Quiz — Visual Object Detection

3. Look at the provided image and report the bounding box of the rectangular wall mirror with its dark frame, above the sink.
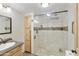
[0,15,12,34]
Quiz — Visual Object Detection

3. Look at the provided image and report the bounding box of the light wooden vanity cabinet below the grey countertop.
[3,46,23,56]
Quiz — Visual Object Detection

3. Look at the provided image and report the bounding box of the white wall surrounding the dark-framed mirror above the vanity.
[0,9,24,42]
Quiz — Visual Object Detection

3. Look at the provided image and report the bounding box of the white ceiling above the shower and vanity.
[4,3,68,14]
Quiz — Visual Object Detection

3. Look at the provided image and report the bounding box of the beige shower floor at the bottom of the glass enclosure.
[35,50,65,56]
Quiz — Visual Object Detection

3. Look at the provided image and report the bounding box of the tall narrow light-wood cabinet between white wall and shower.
[24,16,31,53]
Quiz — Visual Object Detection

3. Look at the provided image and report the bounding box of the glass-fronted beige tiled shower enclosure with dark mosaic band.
[33,10,68,56]
